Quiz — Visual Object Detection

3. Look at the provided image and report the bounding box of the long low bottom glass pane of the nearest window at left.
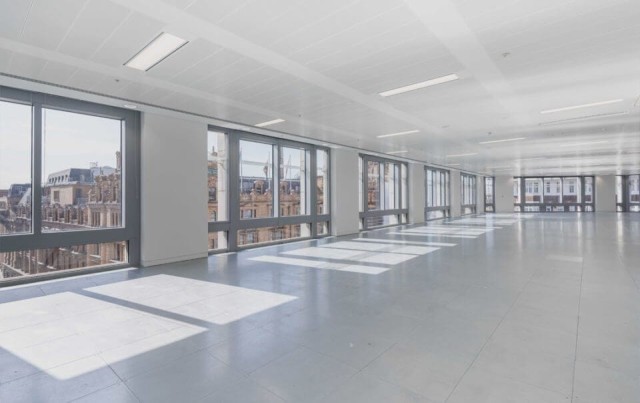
[0,241,128,279]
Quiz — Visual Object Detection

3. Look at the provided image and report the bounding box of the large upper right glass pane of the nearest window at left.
[41,109,123,232]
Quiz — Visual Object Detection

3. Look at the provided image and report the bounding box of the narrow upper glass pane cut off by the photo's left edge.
[0,101,32,235]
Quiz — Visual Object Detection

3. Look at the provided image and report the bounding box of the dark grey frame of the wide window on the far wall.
[513,175,596,213]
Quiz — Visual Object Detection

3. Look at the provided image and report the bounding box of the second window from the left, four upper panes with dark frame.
[207,127,330,252]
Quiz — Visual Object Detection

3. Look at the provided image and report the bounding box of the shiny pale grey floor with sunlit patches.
[0,213,640,403]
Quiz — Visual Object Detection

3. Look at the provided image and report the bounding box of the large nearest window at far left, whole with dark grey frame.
[0,87,140,286]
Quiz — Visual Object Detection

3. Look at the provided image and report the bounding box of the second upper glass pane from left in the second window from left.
[239,140,273,219]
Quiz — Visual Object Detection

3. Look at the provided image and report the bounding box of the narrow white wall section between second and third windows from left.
[331,148,360,235]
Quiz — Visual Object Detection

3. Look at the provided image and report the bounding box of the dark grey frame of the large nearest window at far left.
[0,86,140,286]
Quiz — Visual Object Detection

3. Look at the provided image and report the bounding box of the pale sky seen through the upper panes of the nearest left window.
[0,101,121,189]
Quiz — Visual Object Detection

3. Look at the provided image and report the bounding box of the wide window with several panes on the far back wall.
[514,176,595,212]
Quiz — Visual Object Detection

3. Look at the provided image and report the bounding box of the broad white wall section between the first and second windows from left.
[141,113,208,266]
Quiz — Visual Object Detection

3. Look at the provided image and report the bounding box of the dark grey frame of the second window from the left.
[208,125,332,254]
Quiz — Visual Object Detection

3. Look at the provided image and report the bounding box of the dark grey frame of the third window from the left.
[359,154,410,231]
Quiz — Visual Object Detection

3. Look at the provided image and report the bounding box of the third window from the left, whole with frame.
[358,155,409,229]
